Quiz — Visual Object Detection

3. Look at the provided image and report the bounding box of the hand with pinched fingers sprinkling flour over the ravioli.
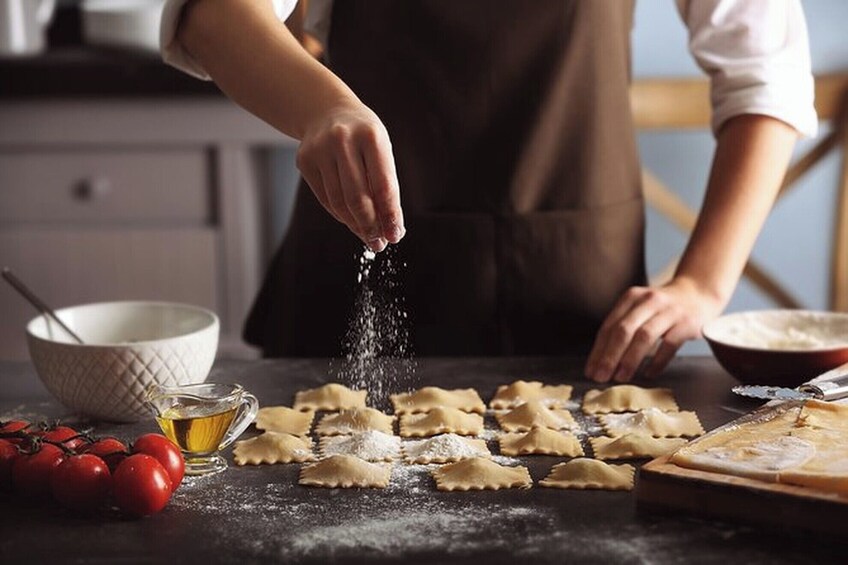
[297,102,405,251]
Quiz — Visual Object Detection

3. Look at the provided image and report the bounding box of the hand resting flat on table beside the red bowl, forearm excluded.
[586,277,724,383]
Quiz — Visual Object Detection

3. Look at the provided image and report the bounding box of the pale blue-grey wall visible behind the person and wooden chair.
[274,0,848,353]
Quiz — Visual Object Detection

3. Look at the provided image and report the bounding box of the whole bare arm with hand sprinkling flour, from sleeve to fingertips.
[176,0,405,251]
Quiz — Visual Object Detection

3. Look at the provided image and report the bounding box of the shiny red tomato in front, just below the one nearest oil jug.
[112,453,171,517]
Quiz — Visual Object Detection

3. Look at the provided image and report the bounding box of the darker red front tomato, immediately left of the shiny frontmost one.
[50,453,112,511]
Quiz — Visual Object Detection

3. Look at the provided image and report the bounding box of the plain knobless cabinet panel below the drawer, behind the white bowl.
[0,228,220,359]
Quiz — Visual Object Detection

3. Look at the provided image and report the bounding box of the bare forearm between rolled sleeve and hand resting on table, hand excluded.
[676,115,797,305]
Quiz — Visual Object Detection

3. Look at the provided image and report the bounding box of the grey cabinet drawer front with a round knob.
[0,149,212,226]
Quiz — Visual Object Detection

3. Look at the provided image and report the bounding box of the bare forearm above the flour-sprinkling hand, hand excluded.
[176,0,358,139]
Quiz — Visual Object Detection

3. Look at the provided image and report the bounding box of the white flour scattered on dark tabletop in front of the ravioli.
[167,465,560,562]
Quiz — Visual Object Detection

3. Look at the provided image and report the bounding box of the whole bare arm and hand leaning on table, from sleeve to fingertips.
[586,115,796,382]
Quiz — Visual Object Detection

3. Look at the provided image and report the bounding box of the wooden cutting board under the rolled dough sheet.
[636,446,848,536]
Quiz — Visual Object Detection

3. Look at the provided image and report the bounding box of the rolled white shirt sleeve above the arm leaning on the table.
[676,0,818,137]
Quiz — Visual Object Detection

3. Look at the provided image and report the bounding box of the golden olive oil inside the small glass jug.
[156,405,238,455]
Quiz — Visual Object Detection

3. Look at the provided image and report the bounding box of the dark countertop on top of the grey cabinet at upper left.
[0,45,223,101]
